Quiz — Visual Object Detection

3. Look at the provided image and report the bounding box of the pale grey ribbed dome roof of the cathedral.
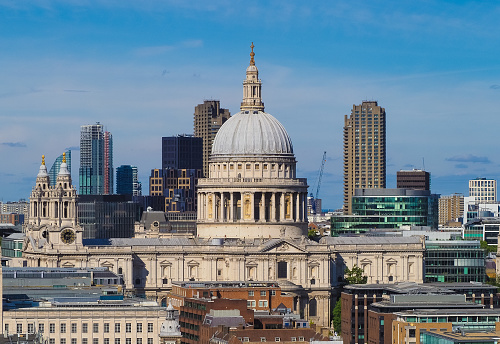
[212,111,293,155]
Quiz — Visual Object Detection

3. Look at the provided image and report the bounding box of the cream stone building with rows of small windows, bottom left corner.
[0,267,174,344]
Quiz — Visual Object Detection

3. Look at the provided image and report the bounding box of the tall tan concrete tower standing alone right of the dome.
[344,101,386,214]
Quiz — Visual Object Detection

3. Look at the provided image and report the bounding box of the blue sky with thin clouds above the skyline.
[0,0,500,208]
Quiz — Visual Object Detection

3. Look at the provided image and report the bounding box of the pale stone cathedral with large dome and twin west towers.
[23,46,424,326]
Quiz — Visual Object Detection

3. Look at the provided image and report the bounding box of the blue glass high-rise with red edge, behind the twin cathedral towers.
[79,122,113,195]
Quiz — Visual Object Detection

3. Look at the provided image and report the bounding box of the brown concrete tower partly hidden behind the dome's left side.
[194,100,231,176]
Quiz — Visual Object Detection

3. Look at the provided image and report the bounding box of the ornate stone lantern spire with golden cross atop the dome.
[240,42,264,111]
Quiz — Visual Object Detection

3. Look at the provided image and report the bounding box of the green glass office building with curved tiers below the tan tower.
[331,189,439,236]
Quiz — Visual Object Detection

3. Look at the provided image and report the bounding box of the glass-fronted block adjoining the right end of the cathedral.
[424,241,486,283]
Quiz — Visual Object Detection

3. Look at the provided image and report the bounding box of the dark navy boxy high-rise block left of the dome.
[161,134,203,170]
